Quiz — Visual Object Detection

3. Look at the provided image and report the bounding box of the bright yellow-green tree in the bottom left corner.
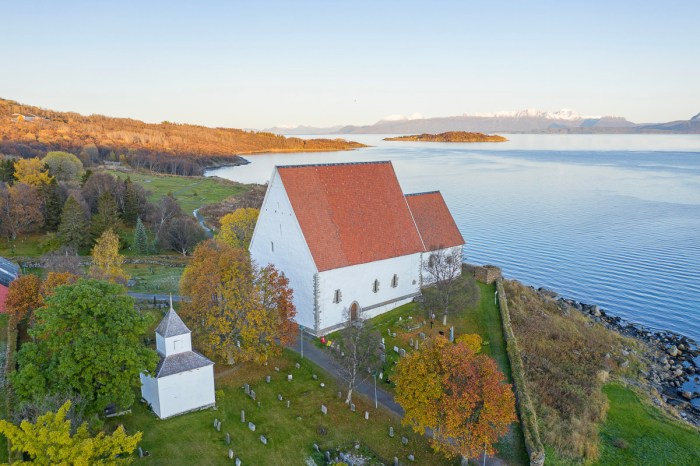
[0,401,143,466]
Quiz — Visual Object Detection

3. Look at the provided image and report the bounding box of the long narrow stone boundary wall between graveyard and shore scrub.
[496,278,545,466]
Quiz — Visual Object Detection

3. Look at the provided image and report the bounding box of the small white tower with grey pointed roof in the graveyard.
[141,302,216,419]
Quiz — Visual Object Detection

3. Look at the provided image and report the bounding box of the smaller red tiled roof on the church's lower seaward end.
[406,191,464,251]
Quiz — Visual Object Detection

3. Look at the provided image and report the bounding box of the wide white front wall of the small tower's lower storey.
[151,365,216,419]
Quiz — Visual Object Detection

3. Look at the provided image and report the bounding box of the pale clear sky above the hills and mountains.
[0,0,700,128]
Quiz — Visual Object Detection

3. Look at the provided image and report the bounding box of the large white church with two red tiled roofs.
[250,162,464,336]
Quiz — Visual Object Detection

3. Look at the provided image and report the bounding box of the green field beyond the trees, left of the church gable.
[107,170,250,214]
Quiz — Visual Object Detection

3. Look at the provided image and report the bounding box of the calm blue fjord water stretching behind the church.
[207,135,700,341]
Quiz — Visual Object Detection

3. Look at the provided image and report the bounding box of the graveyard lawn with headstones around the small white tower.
[108,350,458,465]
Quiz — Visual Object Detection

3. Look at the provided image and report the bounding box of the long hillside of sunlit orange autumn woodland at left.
[0,99,364,173]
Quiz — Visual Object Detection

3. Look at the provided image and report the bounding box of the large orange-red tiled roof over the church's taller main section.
[277,162,424,271]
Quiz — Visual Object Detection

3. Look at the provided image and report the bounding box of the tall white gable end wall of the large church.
[249,168,317,329]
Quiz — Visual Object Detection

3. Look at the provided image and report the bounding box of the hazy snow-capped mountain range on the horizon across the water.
[267,109,700,134]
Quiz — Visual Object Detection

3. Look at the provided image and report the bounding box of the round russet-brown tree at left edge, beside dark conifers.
[0,182,43,240]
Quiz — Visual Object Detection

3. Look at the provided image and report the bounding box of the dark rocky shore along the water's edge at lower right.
[537,288,700,426]
